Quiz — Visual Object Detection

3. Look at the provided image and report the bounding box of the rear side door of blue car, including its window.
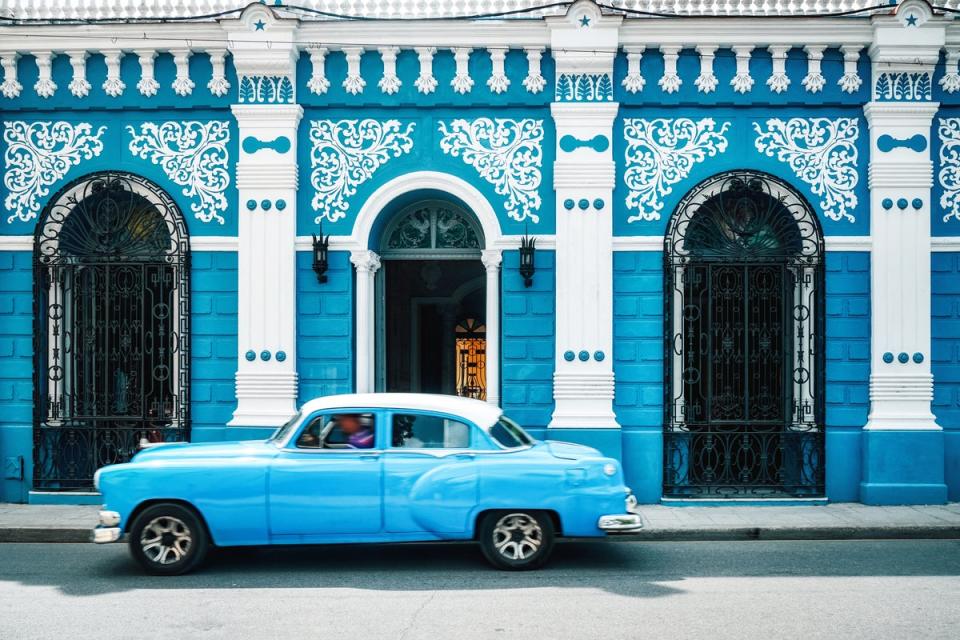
[383,410,478,534]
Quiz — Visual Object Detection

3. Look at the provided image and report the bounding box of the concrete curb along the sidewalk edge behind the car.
[0,525,960,543]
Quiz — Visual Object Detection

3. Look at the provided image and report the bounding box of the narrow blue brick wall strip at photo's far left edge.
[0,251,33,502]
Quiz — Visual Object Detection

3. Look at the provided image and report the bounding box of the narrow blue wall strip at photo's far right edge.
[930,252,960,500]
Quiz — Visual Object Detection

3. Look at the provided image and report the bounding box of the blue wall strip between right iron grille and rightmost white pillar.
[826,251,870,502]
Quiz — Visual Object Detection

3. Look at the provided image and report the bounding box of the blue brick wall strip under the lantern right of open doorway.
[500,250,556,437]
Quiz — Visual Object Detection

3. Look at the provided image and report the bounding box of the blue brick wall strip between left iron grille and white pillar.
[190,251,237,442]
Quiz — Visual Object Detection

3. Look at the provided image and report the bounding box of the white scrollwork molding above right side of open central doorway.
[439,118,544,223]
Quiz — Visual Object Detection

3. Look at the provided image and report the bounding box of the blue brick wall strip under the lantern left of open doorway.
[297,251,354,404]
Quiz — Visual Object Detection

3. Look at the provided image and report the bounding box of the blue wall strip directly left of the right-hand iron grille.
[613,251,663,503]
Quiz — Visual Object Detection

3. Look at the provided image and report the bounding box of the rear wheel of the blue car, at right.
[480,511,554,571]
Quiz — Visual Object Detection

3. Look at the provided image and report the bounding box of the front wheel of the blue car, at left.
[130,503,209,576]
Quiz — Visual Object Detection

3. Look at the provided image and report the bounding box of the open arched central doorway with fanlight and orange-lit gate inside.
[376,199,487,399]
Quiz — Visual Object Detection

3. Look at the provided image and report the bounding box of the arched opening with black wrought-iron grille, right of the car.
[664,171,824,498]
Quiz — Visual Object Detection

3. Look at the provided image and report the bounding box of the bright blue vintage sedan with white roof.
[93,393,641,575]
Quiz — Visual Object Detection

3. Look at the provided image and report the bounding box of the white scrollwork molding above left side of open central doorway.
[310,118,415,223]
